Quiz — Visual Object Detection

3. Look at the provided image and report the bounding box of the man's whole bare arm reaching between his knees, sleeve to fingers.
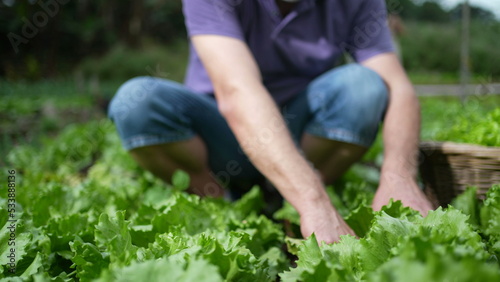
[192,35,353,242]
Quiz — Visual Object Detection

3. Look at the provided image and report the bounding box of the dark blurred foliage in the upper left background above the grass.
[0,0,185,79]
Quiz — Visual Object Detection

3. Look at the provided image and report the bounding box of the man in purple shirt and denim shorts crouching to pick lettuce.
[110,0,432,243]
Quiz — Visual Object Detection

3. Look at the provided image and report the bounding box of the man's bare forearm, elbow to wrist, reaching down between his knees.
[220,83,329,213]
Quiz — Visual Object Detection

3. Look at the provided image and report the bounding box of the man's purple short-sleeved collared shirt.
[183,0,393,104]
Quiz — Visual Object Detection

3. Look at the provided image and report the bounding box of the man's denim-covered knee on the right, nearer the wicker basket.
[308,64,388,146]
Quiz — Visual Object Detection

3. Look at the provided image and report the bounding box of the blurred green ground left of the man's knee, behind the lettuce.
[0,79,121,163]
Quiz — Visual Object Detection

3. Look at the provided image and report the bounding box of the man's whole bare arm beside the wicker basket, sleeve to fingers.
[362,53,433,216]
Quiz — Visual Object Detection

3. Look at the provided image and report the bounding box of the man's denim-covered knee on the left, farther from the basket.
[108,77,200,149]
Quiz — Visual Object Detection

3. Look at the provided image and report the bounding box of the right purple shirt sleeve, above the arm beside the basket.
[347,0,394,62]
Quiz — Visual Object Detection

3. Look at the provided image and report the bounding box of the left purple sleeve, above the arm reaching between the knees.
[182,0,244,40]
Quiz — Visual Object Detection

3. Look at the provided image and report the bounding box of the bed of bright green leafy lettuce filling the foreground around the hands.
[0,121,500,281]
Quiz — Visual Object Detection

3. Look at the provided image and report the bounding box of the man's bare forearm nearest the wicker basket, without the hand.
[382,84,420,178]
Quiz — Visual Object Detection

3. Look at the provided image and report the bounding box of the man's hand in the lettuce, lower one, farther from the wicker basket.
[300,199,356,244]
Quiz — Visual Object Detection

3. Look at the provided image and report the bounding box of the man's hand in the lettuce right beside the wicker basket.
[372,173,434,216]
